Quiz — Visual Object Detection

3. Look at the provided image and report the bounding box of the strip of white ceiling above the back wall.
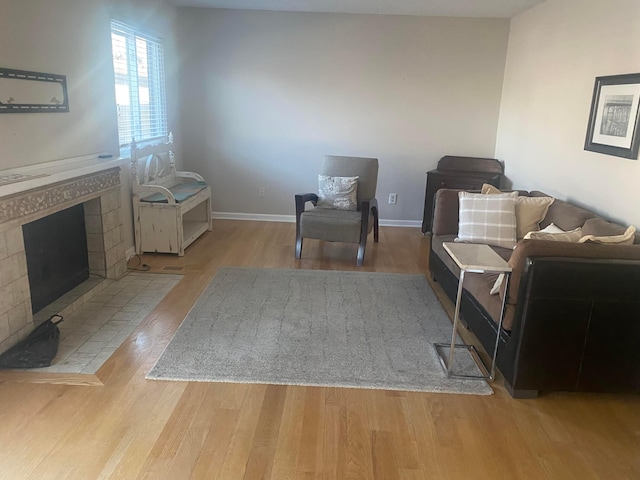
[168,0,544,18]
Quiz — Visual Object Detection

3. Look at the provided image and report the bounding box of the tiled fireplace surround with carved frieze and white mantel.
[0,155,127,352]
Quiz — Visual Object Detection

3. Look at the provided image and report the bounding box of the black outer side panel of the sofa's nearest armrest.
[502,256,640,391]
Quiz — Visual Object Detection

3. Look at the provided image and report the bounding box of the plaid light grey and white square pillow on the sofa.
[457,192,518,248]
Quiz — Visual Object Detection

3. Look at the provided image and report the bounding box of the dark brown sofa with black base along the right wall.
[429,189,640,398]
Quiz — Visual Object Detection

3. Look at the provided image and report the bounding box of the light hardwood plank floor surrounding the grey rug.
[0,220,640,480]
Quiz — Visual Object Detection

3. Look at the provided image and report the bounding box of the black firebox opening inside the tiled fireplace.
[22,204,89,313]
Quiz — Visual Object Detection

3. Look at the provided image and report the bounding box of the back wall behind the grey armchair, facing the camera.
[178,9,509,221]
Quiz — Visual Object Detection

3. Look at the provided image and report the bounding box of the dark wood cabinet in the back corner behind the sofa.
[422,155,504,233]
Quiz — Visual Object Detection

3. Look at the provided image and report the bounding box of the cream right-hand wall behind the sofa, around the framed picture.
[496,0,640,226]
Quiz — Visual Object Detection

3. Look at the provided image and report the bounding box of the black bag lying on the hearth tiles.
[0,314,63,368]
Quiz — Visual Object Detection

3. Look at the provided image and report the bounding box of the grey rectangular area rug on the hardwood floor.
[147,267,493,395]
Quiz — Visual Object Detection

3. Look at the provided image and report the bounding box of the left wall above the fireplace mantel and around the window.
[0,0,179,253]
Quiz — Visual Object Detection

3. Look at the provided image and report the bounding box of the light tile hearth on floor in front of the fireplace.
[23,271,182,374]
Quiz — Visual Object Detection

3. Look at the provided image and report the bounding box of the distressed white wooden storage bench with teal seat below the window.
[131,134,211,257]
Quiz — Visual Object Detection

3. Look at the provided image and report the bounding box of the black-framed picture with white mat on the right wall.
[584,73,640,160]
